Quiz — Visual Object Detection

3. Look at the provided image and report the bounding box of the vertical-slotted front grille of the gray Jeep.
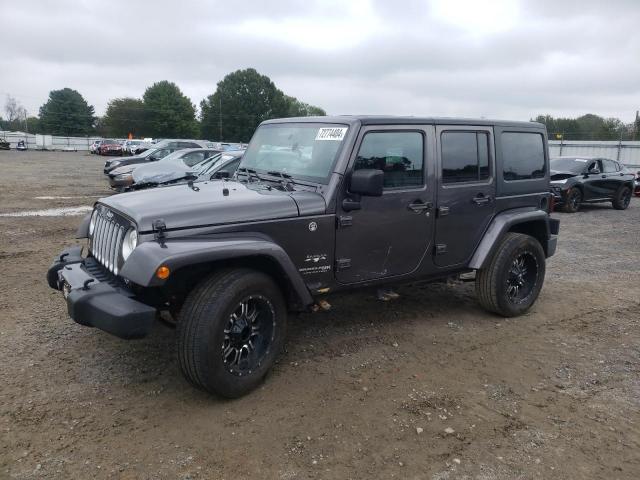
[90,205,128,275]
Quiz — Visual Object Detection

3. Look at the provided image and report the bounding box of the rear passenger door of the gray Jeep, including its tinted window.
[434,125,496,267]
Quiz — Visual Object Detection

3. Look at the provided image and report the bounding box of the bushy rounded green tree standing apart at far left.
[40,88,95,136]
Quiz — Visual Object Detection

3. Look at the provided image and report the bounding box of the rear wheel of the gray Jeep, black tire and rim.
[476,232,545,317]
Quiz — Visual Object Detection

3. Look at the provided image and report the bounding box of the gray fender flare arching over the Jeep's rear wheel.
[469,207,550,270]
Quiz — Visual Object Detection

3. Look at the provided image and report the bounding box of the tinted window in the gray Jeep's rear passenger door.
[440,131,489,184]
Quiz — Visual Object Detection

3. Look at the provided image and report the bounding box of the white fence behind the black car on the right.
[549,140,640,168]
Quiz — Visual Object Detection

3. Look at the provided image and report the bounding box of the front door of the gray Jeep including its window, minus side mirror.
[336,125,434,284]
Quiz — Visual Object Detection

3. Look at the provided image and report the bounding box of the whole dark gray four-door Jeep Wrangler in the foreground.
[48,116,559,397]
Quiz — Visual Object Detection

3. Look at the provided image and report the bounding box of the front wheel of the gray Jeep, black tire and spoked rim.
[177,269,287,398]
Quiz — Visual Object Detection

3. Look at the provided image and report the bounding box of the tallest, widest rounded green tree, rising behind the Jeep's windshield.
[200,68,288,142]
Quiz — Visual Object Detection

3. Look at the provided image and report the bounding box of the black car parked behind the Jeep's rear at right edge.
[551,157,634,213]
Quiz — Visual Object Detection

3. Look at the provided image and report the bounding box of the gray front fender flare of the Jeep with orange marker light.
[120,236,313,307]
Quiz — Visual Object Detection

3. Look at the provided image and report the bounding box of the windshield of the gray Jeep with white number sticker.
[240,123,348,183]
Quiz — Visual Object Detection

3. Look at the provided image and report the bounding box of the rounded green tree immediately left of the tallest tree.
[142,80,198,138]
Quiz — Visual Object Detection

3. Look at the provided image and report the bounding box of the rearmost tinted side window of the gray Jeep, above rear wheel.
[501,132,545,181]
